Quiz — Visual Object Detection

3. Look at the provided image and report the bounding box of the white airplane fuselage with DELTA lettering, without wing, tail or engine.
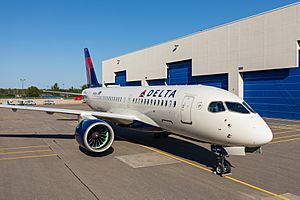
[83,85,273,147]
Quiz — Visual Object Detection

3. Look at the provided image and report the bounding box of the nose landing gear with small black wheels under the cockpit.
[211,145,231,176]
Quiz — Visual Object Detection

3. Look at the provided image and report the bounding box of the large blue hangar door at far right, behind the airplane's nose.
[243,68,300,120]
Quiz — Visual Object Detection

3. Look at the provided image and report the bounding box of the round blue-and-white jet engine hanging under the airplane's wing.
[75,119,114,153]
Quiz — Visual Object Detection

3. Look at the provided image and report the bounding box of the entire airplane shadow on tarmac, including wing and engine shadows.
[0,130,217,168]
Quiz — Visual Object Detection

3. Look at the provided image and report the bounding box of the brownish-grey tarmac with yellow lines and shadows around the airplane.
[0,104,300,200]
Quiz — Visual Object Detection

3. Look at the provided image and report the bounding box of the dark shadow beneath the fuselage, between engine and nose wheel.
[114,127,217,168]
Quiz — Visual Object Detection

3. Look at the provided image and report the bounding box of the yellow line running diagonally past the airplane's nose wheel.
[138,145,288,200]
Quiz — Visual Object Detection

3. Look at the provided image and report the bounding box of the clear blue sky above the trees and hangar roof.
[0,0,297,88]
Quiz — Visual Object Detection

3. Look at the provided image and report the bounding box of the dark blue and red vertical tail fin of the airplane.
[84,48,100,88]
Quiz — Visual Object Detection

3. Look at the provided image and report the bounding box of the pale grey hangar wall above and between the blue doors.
[102,3,300,102]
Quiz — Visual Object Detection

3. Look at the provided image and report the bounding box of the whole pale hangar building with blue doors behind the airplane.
[102,2,300,120]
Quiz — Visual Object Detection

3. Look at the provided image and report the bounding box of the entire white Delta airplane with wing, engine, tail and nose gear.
[0,48,273,176]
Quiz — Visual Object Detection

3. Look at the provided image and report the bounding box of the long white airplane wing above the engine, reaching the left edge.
[0,105,136,124]
